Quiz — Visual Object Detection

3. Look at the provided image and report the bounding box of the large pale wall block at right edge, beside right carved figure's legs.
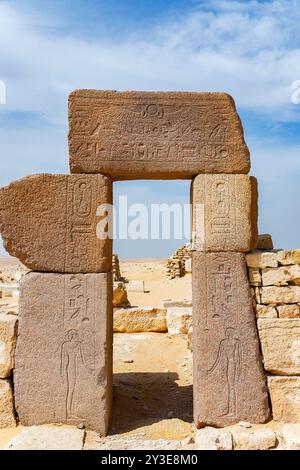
[257,318,300,375]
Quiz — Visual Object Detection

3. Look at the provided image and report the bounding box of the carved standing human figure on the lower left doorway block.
[60,330,86,419]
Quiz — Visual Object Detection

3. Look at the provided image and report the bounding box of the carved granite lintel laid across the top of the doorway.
[69,90,250,179]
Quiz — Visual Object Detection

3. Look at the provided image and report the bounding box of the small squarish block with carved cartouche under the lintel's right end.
[191,175,258,252]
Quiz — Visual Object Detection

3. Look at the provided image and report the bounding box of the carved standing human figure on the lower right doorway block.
[208,328,242,417]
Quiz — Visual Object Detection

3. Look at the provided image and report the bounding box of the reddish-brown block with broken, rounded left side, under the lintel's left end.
[0,174,112,273]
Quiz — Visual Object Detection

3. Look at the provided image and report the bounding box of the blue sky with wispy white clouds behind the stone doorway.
[0,0,300,257]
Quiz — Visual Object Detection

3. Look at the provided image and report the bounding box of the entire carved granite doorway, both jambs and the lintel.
[0,90,270,435]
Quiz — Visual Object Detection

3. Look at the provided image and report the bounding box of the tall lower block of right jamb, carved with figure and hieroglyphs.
[192,252,269,427]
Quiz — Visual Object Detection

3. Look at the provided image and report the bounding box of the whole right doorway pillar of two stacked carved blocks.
[192,175,269,427]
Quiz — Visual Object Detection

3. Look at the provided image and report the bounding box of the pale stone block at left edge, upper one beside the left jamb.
[0,313,17,379]
